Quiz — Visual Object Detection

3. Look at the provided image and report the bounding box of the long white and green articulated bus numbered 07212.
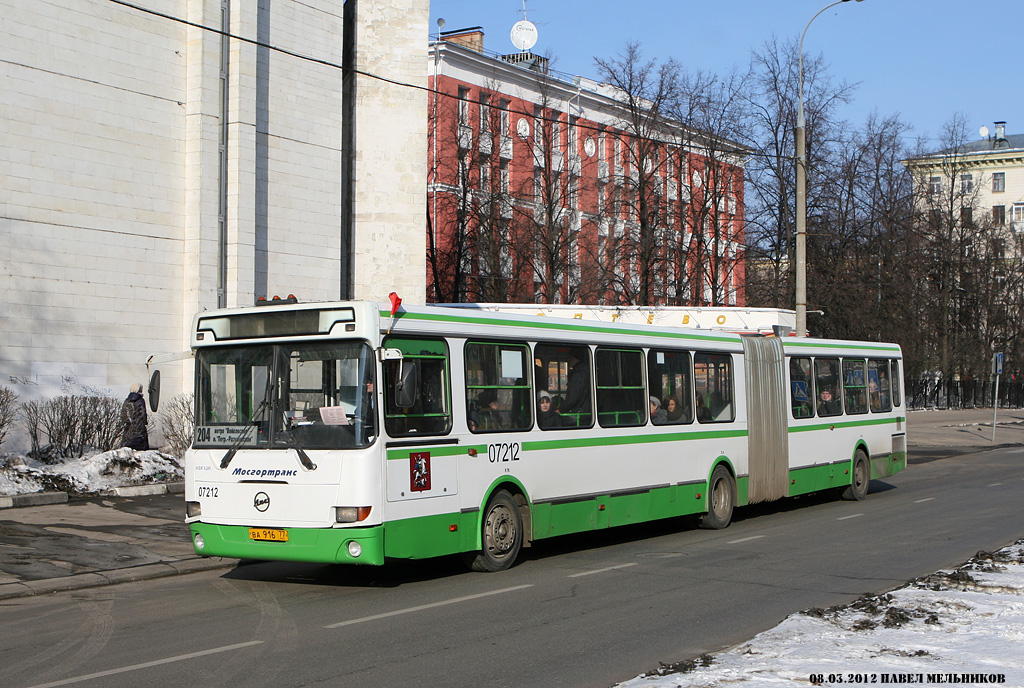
[185,302,906,570]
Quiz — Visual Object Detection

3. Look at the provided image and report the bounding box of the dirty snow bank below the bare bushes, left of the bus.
[0,447,184,497]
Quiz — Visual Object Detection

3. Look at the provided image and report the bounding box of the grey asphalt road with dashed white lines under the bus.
[6,447,1024,688]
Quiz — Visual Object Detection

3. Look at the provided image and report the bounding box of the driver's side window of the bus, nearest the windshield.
[383,337,452,437]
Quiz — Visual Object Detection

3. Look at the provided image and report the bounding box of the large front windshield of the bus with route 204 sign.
[195,342,377,449]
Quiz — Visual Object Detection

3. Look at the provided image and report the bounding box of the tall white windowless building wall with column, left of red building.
[0,0,428,448]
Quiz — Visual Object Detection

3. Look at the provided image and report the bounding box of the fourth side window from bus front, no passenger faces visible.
[594,348,647,428]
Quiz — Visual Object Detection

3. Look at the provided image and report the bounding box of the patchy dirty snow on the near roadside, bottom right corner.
[617,540,1024,688]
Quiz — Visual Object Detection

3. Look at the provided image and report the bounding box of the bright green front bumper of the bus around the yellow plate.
[189,522,384,566]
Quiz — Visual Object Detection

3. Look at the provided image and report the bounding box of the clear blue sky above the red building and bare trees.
[430,0,1024,147]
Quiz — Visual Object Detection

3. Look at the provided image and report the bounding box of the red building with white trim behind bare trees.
[427,29,744,306]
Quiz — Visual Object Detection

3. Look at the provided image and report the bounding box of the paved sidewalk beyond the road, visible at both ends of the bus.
[0,409,1024,600]
